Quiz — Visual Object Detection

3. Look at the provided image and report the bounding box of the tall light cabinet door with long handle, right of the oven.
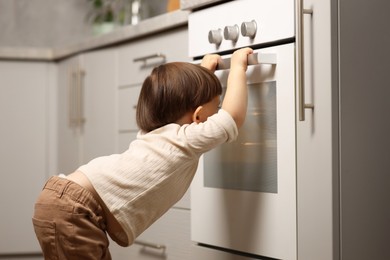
[297,0,337,260]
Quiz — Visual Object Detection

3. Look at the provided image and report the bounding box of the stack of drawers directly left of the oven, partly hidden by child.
[110,27,191,260]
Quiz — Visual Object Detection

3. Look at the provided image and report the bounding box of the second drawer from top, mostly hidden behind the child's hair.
[118,85,141,132]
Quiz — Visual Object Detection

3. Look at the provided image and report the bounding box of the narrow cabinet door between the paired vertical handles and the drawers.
[81,49,117,163]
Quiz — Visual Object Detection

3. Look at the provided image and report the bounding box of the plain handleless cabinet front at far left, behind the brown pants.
[0,60,56,259]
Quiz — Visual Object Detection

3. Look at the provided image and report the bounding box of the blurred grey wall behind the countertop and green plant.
[0,0,171,48]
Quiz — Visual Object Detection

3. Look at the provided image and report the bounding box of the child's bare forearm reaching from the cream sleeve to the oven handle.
[222,48,253,128]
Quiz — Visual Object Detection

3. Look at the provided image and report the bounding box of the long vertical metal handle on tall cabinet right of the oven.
[296,0,314,121]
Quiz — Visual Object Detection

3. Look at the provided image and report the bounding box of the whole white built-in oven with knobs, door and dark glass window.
[189,0,297,260]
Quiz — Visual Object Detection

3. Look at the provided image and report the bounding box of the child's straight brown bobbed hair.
[137,62,222,132]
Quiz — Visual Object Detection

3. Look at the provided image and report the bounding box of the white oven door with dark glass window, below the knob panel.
[191,43,297,259]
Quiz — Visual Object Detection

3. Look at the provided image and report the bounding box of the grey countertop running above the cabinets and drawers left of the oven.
[0,10,189,61]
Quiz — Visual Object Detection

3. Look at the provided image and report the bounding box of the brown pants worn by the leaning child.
[32,177,111,260]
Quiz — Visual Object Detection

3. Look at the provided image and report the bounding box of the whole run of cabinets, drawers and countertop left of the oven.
[0,8,191,260]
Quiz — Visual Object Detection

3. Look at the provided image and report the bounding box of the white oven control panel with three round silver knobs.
[188,0,294,57]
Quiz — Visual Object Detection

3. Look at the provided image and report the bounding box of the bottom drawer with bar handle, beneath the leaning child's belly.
[110,208,191,260]
